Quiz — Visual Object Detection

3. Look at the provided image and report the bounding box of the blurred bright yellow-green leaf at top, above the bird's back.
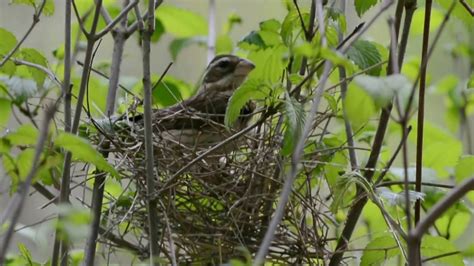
[155,4,207,38]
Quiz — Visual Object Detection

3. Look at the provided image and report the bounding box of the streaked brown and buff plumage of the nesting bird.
[131,55,255,147]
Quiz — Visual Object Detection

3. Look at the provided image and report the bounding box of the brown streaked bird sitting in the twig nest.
[120,54,255,169]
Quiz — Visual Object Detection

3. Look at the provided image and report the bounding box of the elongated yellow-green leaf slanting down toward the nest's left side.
[54,132,119,177]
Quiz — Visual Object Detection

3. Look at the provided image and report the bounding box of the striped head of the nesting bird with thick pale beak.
[199,55,255,92]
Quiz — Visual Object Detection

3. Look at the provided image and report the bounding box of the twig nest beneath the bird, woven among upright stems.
[93,106,334,265]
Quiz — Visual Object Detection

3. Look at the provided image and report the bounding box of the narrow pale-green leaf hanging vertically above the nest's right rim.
[281,93,305,156]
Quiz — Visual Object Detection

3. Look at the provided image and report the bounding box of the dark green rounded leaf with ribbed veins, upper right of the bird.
[347,40,382,76]
